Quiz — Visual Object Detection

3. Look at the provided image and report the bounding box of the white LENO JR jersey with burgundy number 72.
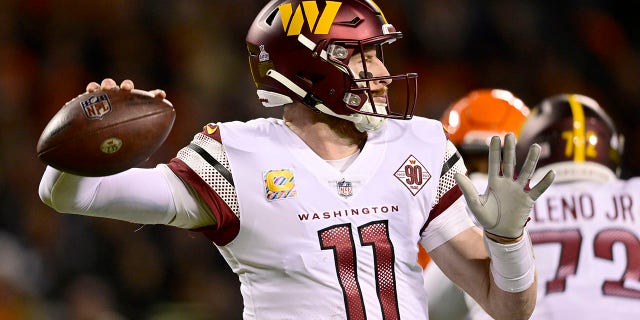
[527,178,640,320]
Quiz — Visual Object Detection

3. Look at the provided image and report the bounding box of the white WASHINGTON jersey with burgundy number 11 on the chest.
[169,117,473,320]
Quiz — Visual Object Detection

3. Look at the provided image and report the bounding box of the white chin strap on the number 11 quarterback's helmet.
[258,69,386,132]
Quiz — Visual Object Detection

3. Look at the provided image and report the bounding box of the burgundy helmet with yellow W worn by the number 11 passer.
[246,0,417,131]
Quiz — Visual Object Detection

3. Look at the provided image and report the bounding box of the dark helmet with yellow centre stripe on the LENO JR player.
[516,94,624,182]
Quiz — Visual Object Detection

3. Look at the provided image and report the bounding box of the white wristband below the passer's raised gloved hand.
[484,230,535,292]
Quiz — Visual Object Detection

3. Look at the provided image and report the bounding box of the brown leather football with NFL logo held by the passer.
[37,89,175,177]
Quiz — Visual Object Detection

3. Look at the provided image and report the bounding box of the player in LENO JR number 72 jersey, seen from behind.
[517,94,640,320]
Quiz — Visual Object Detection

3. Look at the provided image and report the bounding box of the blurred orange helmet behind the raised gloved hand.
[440,89,529,152]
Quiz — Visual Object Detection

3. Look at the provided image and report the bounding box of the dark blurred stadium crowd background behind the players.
[0,0,640,320]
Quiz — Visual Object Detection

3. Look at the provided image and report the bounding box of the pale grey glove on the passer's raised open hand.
[455,133,555,239]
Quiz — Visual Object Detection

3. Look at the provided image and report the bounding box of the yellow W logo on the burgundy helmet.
[278,1,342,36]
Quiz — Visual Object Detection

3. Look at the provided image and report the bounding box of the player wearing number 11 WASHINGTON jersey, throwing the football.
[40,0,554,320]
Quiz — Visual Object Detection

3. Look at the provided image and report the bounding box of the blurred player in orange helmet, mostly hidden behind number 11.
[424,88,529,320]
